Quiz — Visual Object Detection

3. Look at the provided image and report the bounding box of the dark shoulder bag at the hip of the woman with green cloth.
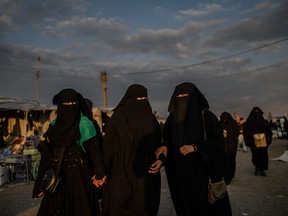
[39,169,60,194]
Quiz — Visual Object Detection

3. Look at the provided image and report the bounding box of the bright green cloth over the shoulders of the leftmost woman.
[51,113,96,153]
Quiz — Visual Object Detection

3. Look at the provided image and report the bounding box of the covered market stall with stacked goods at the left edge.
[0,98,56,185]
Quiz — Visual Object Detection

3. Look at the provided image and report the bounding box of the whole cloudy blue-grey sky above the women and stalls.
[0,0,288,118]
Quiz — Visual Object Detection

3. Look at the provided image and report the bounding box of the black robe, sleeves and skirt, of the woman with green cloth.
[33,137,104,216]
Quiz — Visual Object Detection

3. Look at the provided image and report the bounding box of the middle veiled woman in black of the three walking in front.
[103,84,162,216]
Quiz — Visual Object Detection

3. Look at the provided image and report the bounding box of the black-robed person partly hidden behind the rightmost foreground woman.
[220,112,239,185]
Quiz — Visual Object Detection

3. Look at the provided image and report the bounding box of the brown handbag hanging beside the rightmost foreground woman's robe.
[208,180,227,204]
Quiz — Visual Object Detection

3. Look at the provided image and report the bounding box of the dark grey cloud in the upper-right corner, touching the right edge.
[207,1,288,47]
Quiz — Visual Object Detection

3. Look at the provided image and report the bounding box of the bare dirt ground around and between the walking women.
[0,139,288,216]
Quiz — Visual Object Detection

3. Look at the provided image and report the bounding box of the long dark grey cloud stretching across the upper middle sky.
[43,13,223,58]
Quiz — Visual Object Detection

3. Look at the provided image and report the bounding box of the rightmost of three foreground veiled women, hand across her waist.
[163,82,231,216]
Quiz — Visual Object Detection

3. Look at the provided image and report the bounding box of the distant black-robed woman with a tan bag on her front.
[243,107,272,176]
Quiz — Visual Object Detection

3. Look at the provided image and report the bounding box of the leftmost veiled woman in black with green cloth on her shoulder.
[32,89,106,216]
